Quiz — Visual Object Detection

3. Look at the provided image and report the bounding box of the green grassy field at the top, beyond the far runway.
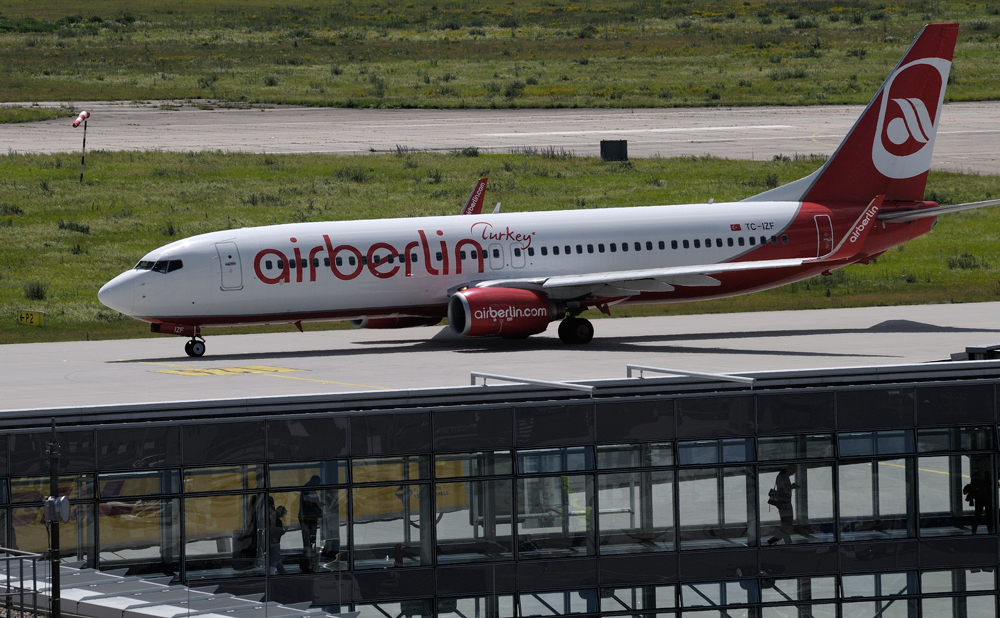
[0,0,1000,108]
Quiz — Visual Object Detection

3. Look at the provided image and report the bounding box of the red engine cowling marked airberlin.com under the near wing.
[448,288,555,338]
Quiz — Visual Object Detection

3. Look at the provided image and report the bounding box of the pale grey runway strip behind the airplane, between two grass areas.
[0,101,1000,174]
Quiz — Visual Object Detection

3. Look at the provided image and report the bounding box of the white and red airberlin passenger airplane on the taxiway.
[98,24,1000,356]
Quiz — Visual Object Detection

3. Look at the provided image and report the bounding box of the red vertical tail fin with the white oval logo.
[749,24,958,203]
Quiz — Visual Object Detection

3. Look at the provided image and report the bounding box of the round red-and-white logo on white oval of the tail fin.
[872,58,951,179]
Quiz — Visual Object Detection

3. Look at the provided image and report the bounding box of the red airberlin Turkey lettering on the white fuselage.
[253,222,533,285]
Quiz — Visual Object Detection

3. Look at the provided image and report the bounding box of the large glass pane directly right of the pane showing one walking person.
[838,459,916,541]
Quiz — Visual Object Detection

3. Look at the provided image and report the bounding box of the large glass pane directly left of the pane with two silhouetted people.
[184,494,267,579]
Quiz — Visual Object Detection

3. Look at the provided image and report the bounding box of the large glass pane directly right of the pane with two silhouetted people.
[352,485,434,569]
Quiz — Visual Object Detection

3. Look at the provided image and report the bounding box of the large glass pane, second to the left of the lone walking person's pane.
[598,470,674,554]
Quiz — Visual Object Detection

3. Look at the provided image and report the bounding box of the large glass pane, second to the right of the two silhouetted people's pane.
[435,479,514,564]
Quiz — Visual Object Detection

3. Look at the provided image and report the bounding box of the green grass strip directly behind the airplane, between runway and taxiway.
[0,150,1000,343]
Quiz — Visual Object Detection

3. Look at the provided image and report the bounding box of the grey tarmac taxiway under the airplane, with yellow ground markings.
[7,302,1000,410]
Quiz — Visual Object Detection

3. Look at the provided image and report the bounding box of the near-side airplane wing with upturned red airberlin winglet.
[473,195,885,299]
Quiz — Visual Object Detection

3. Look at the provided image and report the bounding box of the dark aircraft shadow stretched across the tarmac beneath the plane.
[115,320,1000,363]
